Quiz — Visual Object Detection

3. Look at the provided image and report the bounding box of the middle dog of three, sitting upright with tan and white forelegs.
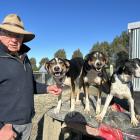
[77,51,109,114]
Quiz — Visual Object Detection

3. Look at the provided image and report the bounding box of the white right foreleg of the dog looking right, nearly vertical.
[128,98,139,126]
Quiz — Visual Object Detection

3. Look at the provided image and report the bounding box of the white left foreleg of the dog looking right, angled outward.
[95,94,113,122]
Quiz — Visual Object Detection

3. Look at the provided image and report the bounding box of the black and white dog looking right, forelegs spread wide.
[96,58,140,126]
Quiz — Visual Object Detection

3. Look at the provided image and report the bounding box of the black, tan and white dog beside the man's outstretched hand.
[45,58,84,113]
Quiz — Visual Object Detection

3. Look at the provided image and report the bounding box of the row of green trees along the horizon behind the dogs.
[30,31,129,71]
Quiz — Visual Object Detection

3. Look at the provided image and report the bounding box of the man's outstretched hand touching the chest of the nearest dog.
[47,85,62,95]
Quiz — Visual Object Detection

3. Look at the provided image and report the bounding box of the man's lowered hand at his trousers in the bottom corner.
[0,124,17,140]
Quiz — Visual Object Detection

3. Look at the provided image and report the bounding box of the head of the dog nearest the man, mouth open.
[45,58,70,79]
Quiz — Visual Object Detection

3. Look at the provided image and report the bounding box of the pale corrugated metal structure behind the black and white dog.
[128,22,140,91]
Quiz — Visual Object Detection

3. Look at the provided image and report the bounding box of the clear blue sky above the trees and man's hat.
[0,0,140,65]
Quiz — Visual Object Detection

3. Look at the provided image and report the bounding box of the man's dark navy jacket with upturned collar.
[0,45,47,124]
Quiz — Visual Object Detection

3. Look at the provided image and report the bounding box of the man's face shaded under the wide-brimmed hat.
[0,30,24,53]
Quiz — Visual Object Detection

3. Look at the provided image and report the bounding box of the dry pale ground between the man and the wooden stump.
[30,89,96,140]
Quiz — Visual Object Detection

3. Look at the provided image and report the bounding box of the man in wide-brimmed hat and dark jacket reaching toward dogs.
[0,14,61,140]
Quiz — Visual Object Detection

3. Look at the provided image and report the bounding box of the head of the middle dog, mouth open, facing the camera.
[86,51,107,72]
